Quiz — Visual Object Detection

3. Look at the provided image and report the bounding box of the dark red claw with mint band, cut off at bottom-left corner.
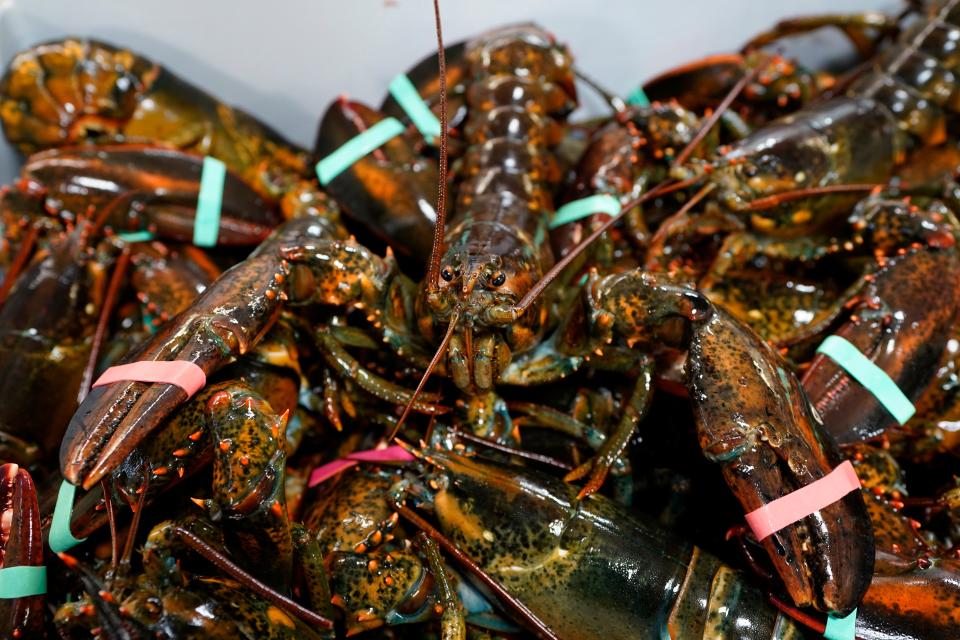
[0,463,45,638]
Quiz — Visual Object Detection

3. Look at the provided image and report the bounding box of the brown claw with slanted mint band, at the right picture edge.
[803,249,960,444]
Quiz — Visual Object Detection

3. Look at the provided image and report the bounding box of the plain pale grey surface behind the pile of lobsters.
[0,0,899,182]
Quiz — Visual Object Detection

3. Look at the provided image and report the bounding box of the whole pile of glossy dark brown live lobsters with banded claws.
[0,0,960,640]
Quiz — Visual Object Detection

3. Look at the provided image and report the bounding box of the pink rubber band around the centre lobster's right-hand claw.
[747,460,860,540]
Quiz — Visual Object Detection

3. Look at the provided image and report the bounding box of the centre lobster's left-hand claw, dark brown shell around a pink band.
[60,218,343,489]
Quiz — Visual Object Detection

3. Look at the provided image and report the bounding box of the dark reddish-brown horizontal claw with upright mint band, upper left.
[22,145,283,246]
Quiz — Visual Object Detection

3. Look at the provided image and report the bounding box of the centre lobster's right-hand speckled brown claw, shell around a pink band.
[592,271,874,615]
